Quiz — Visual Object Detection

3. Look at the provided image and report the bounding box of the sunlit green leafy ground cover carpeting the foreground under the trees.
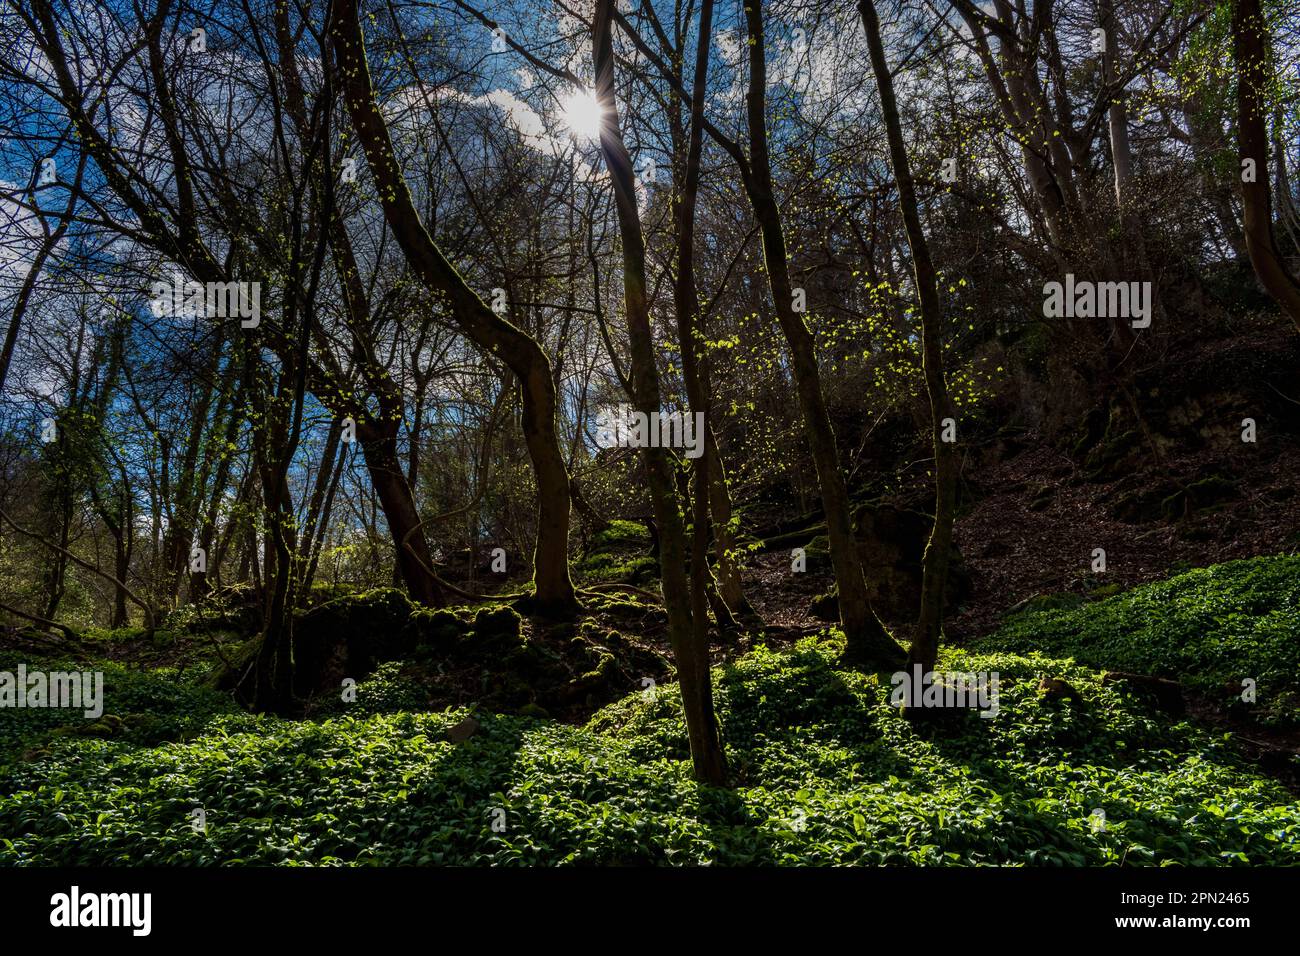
[0,606,1300,866]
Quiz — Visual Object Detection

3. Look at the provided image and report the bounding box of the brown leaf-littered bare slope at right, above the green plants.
[744,434,1300,644]
